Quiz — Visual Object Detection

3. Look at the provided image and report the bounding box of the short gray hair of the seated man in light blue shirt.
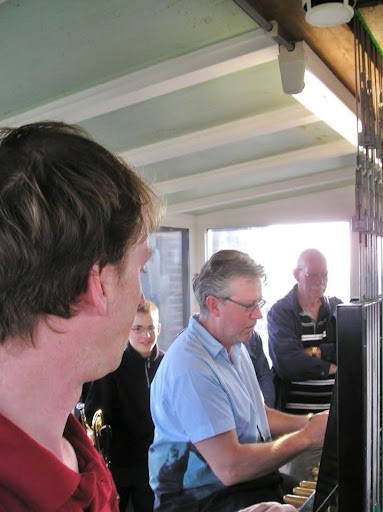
[193,249,266,313]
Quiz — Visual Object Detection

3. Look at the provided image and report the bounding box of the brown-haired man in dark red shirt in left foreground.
[0,122,160,512]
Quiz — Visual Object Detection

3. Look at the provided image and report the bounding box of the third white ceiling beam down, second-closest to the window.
[153,139,355,195]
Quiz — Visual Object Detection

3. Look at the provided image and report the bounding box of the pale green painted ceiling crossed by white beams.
[0,0,376,220]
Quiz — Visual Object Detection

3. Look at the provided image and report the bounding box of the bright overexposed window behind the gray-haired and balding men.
[207,222,350,360]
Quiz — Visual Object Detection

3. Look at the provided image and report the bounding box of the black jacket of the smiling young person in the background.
[85,345,163,480]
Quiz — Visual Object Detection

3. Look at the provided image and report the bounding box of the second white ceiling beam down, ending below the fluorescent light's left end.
[120,102,318,167]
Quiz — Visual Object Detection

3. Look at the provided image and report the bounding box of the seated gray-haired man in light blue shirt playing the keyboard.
[149,250,327,512]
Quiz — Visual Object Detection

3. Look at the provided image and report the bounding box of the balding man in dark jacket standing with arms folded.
[267,249,341,480]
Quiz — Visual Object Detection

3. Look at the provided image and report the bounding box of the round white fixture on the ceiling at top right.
[302,0,355,27]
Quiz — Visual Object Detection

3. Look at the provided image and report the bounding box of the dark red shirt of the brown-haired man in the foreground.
[0,414,118,512]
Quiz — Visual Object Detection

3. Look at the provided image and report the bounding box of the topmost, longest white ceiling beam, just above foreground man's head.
[2,29,278,126]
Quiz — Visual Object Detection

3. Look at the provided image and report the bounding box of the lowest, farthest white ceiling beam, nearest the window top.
[166,166,355,215]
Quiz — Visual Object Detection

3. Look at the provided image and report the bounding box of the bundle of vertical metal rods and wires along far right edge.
[354,17,383,512]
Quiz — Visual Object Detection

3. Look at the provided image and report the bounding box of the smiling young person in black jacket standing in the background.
[85,301,163,512]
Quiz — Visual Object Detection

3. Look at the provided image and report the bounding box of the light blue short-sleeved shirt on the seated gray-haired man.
[149,315,270,510]
